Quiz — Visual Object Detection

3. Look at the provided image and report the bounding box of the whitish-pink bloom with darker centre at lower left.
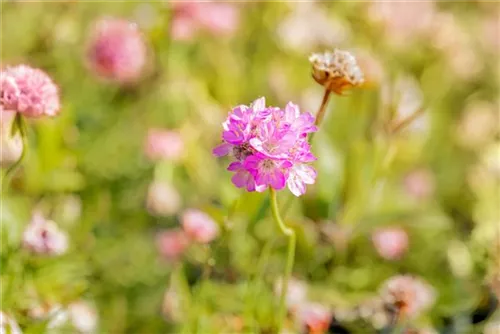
[23,212,68,255]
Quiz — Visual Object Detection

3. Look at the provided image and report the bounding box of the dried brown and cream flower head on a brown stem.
[309,49,364,95]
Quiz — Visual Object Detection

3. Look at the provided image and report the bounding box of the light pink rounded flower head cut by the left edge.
[0,65,60,117]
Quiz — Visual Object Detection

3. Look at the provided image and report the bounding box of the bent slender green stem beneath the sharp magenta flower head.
[269,188,296,333]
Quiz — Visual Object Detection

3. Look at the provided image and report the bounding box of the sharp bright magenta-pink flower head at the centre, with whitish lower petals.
[213,97,317,196]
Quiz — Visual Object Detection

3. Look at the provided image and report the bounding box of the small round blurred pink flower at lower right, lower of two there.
[372,227,408,260]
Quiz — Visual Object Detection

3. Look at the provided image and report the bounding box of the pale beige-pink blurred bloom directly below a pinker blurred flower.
[146,181,182,216]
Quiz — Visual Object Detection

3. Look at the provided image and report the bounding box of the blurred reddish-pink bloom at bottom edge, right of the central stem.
[296,303,333,333]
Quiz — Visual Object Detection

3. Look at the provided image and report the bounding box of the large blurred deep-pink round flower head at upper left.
[87,18,148,84]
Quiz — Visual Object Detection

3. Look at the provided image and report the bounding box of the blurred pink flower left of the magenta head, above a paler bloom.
[144,129,184,161]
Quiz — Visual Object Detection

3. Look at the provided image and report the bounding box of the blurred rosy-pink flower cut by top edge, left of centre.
[171,1,239,40]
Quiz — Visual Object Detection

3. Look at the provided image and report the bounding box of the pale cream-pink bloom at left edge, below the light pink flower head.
[0,110,23,167]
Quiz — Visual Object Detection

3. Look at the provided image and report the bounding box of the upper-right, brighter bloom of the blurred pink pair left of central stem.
[182,209,219,244]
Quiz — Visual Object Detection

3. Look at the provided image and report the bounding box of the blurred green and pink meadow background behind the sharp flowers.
[0,0,500,334]
